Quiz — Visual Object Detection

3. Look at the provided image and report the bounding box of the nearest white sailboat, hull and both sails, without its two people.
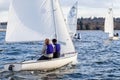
[4,0,77,71]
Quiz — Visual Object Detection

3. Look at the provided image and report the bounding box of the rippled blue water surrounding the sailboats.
[0,31,120,80]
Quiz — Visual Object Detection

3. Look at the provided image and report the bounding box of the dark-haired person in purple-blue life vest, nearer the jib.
[52,39,61,58]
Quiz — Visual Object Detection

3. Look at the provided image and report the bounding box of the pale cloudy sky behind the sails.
[0,0,120,22]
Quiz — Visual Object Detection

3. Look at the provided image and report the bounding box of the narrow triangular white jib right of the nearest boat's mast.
[53,0,75,53]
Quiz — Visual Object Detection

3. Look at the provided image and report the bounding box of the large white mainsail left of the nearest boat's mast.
[6,0,54,42]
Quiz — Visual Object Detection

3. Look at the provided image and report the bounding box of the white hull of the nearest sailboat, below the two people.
[4,53,77,71]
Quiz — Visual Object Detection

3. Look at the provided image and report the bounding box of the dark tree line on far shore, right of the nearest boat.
[77,17,120,30]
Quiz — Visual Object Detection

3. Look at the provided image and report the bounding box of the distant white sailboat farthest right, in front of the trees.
[104,8,119,40]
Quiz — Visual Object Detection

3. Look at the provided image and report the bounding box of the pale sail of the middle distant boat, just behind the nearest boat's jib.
[67,2,78,36]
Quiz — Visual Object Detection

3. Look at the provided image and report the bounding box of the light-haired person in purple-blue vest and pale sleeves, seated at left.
[38,39,53,60]
